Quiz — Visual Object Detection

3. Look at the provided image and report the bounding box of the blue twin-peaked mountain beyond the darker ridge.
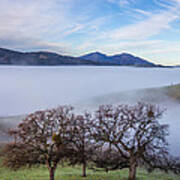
[80,52,157,67]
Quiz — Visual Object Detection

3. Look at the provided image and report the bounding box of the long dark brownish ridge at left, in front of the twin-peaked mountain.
[0,48,99,66]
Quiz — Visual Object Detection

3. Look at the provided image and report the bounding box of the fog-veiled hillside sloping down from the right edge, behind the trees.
[75,84,180,109]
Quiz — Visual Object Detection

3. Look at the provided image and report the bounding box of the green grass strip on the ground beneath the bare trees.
[0,166,180,180]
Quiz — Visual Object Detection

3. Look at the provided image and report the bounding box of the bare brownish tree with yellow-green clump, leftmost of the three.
[3,106,74,180]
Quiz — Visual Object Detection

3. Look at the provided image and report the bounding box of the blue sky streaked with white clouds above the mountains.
[0,0,180,65]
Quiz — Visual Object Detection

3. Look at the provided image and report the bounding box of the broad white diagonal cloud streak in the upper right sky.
[102,11,180,40]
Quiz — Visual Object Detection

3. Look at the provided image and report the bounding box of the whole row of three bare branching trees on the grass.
[1,103,180,180]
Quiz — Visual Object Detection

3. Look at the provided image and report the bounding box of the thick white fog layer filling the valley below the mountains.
[0,66,180,155]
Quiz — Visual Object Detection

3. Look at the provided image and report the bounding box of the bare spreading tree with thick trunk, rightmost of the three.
[94,103,174,180]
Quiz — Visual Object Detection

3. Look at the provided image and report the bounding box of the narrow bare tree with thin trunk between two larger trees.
[70,113,98,177]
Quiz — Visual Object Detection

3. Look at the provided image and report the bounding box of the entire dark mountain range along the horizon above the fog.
[0,48,169,67]
